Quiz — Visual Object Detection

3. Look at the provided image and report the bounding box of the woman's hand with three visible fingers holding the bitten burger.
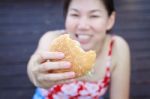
[32,52,75,88]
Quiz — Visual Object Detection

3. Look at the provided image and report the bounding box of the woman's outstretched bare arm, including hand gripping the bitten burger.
[27,31,75,88]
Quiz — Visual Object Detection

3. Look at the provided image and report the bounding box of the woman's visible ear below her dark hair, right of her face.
[107,12,116,30]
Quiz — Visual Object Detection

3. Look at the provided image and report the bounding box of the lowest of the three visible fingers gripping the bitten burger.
[38,72,75,83]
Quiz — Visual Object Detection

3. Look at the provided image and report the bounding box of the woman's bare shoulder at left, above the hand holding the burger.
[37,30,65,50]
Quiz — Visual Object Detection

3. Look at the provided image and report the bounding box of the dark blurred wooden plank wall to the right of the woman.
[115,0,150,99]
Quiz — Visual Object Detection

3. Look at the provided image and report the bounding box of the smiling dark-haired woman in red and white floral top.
[28,0,130,99]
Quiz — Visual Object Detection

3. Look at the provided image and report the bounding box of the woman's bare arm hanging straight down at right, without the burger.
[110,37,130,99]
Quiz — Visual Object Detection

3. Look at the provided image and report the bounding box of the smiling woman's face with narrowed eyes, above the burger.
[65,0,113,50]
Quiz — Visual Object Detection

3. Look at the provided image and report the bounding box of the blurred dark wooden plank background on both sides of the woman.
[0,0,150,99]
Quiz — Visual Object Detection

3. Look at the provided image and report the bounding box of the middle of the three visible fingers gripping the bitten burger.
[38,61,71,72]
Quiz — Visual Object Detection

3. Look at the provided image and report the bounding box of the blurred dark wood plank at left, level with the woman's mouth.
[0,32,41,46]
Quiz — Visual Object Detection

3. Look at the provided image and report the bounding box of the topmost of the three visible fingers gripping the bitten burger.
[37,52,64,63]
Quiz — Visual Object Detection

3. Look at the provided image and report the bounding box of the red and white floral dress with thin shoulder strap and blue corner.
[33,39,114,99]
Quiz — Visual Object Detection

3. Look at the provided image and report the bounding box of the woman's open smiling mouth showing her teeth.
[75,33,92,44]
